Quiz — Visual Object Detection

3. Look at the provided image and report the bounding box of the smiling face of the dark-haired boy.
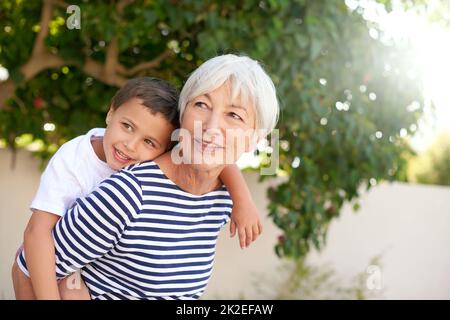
[103,98,175,170]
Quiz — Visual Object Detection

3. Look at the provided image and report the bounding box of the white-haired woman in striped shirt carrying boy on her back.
[34,55,278,299]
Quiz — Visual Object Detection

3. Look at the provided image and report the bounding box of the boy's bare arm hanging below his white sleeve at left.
[24,210,60,300]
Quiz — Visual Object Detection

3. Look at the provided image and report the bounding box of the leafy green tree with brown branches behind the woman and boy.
[0,0,423,257]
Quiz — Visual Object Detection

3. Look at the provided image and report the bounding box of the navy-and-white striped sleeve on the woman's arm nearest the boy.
[53,170,142,278]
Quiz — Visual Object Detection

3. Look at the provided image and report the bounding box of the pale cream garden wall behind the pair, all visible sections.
[0,149,450,299]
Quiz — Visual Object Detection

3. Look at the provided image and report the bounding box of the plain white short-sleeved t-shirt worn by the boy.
[30,128,115,216]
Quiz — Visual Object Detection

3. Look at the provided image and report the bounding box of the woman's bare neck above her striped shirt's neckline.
[155,152,222,195]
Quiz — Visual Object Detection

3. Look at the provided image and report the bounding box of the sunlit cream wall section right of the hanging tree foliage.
[312,183,450,299]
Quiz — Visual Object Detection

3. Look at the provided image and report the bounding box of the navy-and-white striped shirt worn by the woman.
[19,161,232,299]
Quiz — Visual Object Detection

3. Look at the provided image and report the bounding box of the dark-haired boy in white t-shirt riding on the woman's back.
[13,78,261,299]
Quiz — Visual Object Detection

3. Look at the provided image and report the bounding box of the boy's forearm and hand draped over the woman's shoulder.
[220,164,262,248]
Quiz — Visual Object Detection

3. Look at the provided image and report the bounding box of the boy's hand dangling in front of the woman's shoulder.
[230,201,262,249]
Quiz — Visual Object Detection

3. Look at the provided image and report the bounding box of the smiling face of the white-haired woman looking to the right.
[180,82,256,170]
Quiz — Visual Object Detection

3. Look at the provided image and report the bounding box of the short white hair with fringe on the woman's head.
[178,54,279,137]
